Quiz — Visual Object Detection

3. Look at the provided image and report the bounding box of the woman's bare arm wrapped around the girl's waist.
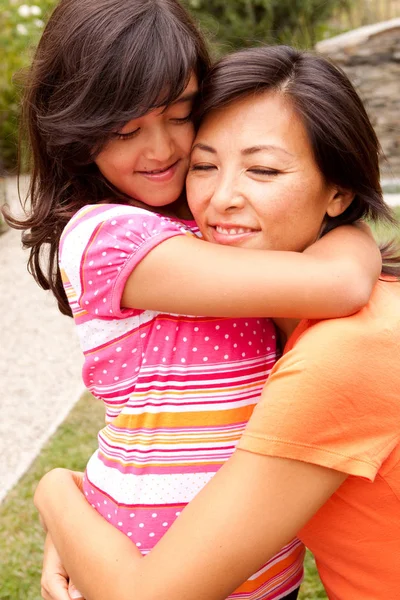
[35,450,346,600]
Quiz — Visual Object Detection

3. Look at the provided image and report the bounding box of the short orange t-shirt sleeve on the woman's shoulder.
[238,319,400,480]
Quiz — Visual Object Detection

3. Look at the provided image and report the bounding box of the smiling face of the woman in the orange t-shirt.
[187,93,351,251]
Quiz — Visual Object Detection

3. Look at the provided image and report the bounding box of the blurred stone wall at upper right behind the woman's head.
[316,18,400,177]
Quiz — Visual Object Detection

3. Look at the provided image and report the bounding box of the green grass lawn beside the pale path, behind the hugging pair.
[0,207,400,600]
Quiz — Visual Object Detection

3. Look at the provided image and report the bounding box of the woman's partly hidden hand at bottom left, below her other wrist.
[41,534,83,600]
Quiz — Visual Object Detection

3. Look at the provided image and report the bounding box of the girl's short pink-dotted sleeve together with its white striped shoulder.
[60,205,192,318]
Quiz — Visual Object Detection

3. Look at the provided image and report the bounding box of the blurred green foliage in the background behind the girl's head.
[0,0,352,171]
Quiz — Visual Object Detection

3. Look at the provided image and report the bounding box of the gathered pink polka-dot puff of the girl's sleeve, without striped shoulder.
[79,205,191,318]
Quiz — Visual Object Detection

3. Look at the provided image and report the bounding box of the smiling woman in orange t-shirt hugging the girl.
[36,47,400,600]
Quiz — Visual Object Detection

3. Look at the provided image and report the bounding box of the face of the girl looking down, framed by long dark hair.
[95,75,198,208]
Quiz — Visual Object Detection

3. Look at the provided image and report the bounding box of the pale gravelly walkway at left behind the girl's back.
[0,179,83,502]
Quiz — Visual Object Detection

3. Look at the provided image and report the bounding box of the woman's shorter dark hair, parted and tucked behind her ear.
[196,46,400,277]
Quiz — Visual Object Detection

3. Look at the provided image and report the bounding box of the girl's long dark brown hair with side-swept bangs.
[6,0,210,315]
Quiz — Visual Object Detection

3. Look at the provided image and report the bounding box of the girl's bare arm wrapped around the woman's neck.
[121,226,382,319]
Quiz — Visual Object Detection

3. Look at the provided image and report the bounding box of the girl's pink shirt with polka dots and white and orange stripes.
[60,204,303,600]
